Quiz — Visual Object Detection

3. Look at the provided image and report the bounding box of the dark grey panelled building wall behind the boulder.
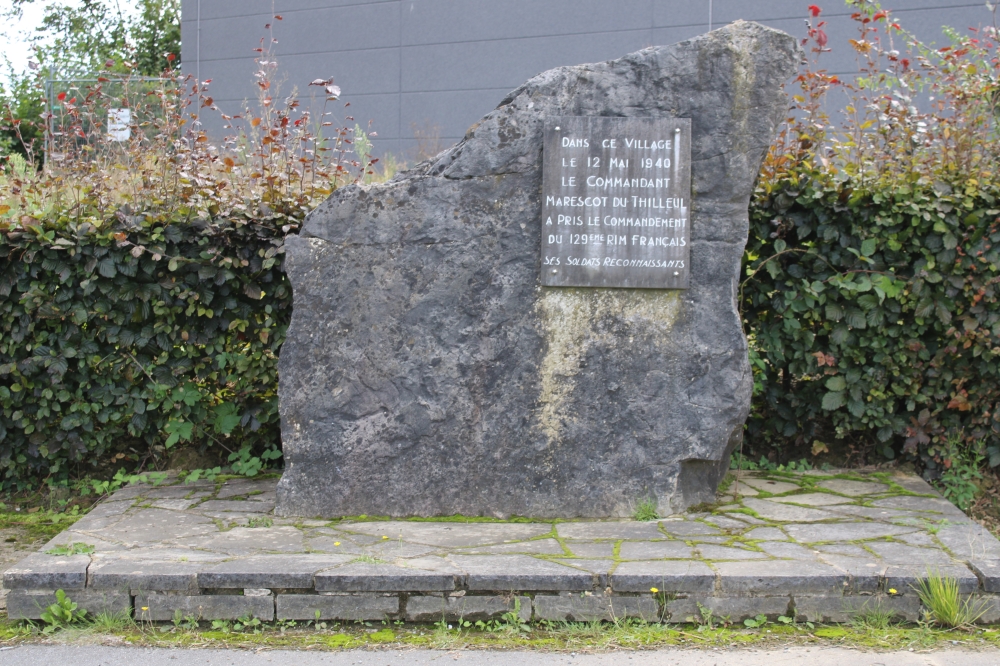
[182,0,993,158]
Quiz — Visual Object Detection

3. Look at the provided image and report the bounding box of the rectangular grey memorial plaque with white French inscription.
[541,116,691,289]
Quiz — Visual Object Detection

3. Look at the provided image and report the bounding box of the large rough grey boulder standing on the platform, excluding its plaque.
[277,21,799,517]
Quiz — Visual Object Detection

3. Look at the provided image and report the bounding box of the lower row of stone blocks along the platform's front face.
[7,589,1000,624]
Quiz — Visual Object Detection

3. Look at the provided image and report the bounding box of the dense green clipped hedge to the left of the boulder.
[0,215,291,490]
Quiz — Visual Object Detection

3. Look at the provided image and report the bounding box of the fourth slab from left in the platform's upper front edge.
[315,556,458,592]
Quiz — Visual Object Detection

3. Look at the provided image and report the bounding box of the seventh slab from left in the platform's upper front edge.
[713,560,848,596]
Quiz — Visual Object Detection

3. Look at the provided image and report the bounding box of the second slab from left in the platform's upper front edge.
[87,557,207,592]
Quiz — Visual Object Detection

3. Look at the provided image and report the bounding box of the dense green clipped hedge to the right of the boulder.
[742,170,1000,472]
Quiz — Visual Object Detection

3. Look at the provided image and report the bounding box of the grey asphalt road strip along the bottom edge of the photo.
[0,645,1000,666]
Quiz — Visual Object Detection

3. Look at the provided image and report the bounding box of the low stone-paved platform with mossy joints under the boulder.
[3,471,1000,623]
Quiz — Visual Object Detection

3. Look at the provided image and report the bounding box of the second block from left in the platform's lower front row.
[135,594,276,622]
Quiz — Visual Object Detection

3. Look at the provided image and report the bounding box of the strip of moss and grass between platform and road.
[0,614,1000,652]
